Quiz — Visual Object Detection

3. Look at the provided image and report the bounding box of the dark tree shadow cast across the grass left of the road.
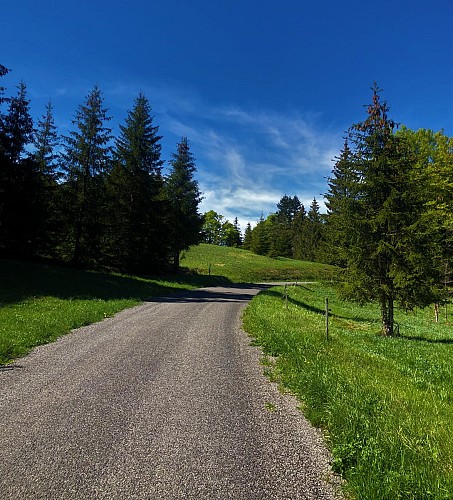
[0,259,228,305]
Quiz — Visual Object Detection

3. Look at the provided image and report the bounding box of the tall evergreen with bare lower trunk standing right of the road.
[328,85,435,335]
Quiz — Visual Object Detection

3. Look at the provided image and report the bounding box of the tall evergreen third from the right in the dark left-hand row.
[62,86,112,264]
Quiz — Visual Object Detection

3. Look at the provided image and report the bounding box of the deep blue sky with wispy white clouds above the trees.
[0,0,453,228]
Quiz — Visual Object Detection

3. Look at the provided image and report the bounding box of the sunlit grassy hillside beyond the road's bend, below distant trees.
[181,244,334,283]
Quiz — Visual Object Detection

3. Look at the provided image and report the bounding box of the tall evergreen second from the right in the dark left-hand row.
[107,93,163,273]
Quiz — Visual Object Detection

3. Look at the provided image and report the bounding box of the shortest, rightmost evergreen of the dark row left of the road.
[165,137,203,270]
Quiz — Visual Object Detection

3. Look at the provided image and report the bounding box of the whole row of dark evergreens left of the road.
[0,65,202,274]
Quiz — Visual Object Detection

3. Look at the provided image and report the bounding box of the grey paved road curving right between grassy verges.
[0,286,340,500]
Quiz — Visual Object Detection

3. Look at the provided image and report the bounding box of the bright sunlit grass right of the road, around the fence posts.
[244,285,453,500]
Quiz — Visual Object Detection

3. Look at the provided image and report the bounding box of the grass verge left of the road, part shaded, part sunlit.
[0,260,226,364]
